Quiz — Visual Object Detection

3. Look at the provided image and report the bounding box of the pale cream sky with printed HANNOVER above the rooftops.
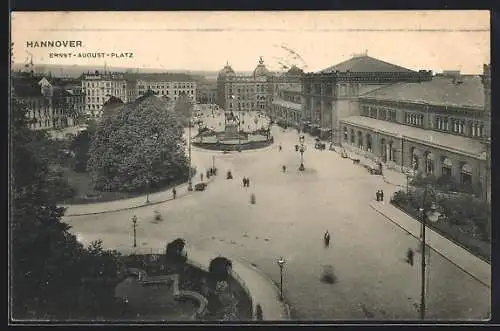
[11,11,490,74]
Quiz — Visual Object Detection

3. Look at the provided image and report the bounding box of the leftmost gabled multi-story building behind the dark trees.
[11,73,85,130]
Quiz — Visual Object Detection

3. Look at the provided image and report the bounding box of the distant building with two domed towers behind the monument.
[217,58,273,111]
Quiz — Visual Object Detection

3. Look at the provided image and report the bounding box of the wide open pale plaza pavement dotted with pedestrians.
[65,116,491,320]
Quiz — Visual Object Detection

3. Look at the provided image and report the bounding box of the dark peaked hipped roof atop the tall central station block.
[320,55,415,73]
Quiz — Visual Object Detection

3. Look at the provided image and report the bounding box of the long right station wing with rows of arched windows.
[339,66,490,197]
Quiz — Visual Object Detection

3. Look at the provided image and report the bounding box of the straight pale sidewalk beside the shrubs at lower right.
[370,201,491,288]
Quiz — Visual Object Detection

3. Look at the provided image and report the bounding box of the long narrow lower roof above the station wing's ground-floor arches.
[340,116,485,159]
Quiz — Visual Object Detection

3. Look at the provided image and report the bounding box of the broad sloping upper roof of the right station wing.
[360,75,484,108]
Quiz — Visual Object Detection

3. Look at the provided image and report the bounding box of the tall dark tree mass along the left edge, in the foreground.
[9,100,119,319]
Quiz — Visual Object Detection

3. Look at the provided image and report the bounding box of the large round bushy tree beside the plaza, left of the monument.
[87,96,189,192]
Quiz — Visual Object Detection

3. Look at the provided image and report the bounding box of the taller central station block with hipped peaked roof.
[302,53,432,139]
